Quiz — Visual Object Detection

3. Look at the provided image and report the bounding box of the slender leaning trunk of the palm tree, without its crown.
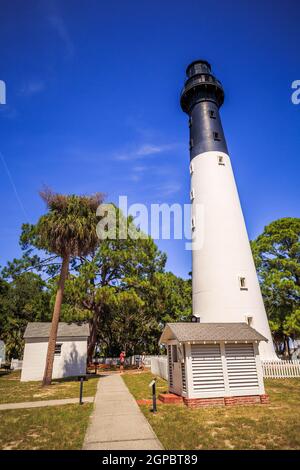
[42,255,70,387]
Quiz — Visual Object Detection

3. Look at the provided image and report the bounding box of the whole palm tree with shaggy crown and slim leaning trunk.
[35,189,103,386]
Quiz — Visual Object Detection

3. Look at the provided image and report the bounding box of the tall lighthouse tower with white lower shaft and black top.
[181,60,277,360]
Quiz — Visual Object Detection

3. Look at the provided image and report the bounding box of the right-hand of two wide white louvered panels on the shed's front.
[225,344,259,391]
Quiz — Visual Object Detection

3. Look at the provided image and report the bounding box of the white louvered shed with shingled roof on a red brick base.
[160,322,268,406]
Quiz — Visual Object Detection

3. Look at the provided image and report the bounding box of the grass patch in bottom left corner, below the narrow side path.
[0,404,93,450]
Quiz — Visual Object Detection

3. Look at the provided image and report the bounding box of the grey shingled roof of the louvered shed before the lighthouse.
[159,322,268,344]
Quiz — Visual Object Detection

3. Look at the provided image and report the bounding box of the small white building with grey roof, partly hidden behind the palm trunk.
[21,322,89,382]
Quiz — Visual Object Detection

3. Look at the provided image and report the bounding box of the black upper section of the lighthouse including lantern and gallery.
[180,60,228,159]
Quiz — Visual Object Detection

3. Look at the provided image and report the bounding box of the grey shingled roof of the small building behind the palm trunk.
[24,322,90,339]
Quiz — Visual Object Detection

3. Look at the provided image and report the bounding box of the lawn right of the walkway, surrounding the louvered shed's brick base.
[123,372,300,450]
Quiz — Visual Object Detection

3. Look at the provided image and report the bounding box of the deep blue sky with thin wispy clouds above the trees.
[0,0,300,277]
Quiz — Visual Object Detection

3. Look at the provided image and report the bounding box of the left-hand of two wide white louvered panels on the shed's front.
[191,344,225,396]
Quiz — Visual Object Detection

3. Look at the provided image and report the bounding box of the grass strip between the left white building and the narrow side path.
[0,371,99,403]
